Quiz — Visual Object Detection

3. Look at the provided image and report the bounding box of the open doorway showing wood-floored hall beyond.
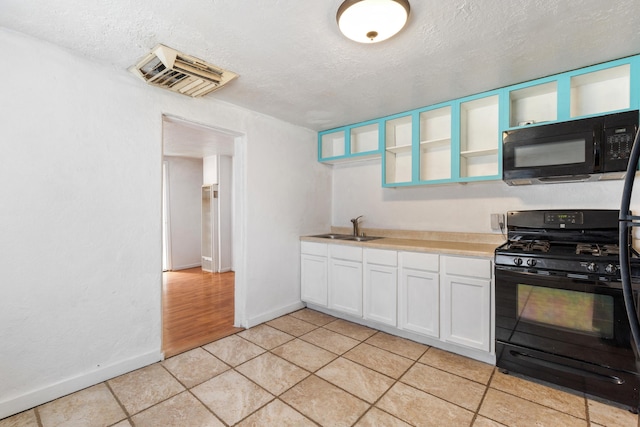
[162,116,241,357]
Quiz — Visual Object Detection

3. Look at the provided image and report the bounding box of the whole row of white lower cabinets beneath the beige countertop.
[301,242,494,360]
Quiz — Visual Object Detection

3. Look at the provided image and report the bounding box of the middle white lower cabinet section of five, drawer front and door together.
[364,248,398,326]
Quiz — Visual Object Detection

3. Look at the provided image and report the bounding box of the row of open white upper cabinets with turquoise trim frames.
[318,55,640,187]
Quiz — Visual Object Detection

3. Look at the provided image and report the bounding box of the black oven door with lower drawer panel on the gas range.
[495,266,640,411]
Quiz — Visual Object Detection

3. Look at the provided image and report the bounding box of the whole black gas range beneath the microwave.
[495,209,640,411]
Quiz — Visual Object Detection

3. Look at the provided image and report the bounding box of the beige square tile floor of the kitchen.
[0,309,638,427]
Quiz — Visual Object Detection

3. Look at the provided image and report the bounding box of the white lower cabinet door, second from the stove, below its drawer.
[399,268,440,338]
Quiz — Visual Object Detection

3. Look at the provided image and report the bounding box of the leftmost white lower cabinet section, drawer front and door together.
[300,242,329,307]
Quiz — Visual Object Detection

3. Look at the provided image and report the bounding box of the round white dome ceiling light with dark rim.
[336,0,410,43]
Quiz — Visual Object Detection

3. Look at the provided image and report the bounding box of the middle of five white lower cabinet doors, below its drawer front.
[364,264,398,326]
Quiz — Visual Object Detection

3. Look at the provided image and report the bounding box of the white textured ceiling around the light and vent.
[0,0,640,130]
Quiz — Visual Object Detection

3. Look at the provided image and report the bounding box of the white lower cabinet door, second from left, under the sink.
[329,258,362,317]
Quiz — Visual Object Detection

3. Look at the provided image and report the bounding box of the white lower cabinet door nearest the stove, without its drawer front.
[441,274,491,351]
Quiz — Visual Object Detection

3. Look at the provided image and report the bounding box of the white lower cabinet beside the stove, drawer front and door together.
[440,256,492,351]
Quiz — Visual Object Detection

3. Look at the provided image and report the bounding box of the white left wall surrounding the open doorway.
[0,29,331,418]
